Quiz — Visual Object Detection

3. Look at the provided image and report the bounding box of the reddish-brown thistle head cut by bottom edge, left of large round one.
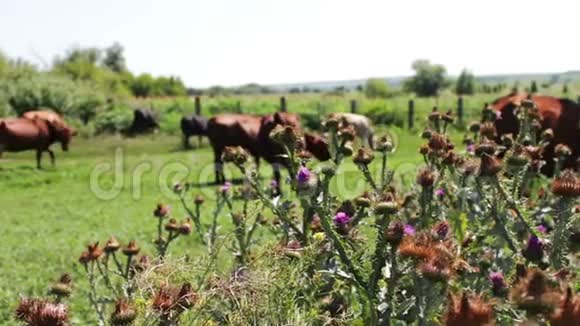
[445,293,494,326]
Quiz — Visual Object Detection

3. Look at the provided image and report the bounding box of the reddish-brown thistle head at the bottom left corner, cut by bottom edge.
[15,298,69,326]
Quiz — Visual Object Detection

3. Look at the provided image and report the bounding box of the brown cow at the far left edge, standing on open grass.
[0,118,73,169]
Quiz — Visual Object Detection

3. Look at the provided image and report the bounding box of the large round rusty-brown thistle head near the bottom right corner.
[510,269,560,315]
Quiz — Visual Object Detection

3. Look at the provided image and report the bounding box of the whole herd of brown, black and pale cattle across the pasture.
[0,93,580,184]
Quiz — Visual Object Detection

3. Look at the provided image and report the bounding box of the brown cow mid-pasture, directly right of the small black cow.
[207,113,261,183]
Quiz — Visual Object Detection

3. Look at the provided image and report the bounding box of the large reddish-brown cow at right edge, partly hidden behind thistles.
[492,93,580,175]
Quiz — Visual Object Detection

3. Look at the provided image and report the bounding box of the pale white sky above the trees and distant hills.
[0,0,580,87]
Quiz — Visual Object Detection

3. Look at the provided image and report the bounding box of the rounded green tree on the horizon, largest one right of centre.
[404,60,446,96]
